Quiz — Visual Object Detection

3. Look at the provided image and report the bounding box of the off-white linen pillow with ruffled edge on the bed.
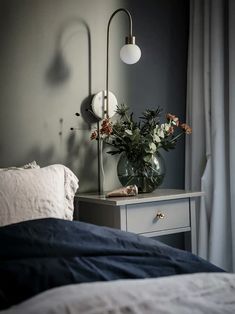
[0,165,78,226]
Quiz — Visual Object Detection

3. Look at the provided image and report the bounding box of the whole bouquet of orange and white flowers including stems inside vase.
[91,104,192,190]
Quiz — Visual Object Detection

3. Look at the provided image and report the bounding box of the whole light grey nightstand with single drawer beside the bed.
[77,189,203,253]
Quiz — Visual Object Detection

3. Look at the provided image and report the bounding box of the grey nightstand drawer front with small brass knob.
[127,199,190,233]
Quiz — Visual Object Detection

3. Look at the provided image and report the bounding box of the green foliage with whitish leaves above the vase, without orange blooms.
[103,104,188,163]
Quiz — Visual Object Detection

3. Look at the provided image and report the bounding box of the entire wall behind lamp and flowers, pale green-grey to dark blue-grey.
[0,0,188,191]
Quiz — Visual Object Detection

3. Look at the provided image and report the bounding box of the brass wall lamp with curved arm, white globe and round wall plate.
[91,8,141,120]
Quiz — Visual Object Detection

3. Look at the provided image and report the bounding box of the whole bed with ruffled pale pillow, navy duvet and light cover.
[0,165,235,314]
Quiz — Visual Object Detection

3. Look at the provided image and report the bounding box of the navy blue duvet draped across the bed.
[0,218,222,309]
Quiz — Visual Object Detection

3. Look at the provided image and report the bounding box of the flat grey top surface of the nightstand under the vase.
[76,189,204,206]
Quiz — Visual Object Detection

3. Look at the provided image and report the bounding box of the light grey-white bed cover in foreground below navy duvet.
[2,273,235,314]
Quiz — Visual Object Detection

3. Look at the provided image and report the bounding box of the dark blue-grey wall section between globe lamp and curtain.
[125,0,189,188]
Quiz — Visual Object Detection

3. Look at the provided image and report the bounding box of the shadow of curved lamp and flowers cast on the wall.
[46,17,98,189]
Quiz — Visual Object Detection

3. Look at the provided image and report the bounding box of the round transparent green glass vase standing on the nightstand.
[117,152,166,193]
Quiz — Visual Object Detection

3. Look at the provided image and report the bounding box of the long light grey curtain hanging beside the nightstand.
[185,0,235,270]
